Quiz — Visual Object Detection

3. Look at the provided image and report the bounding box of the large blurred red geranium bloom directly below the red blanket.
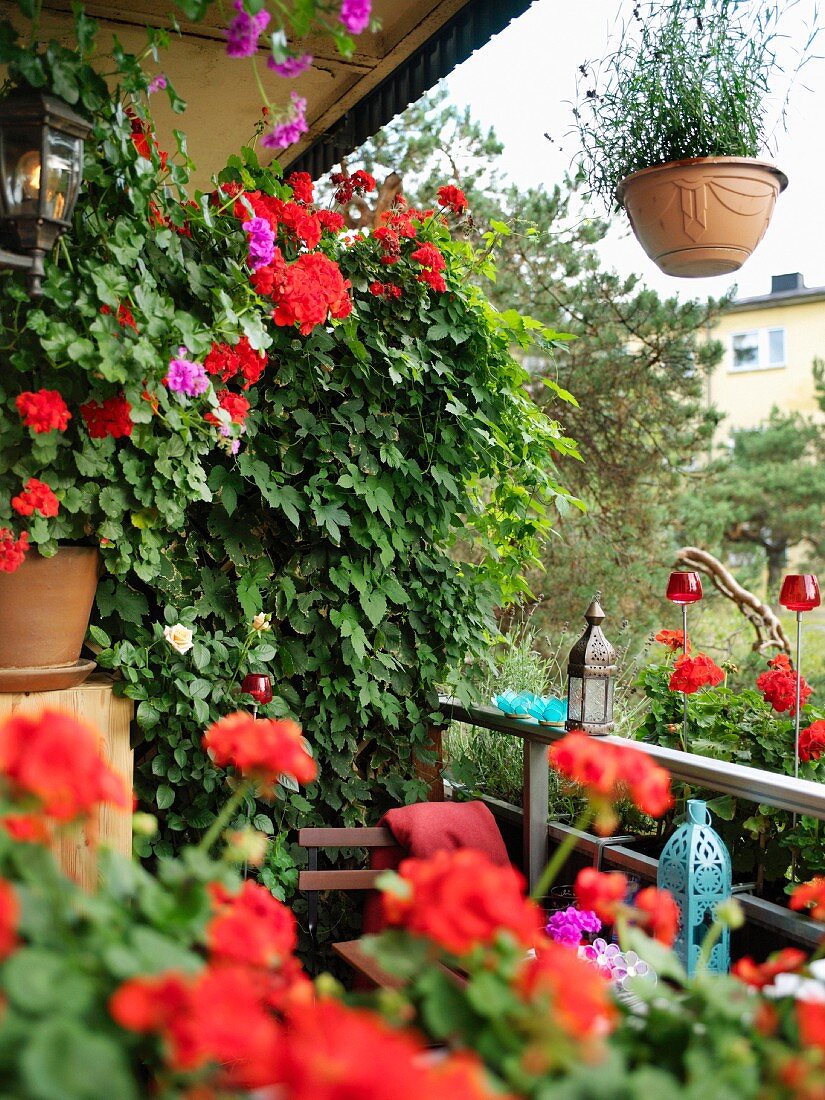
[382,848,541,955]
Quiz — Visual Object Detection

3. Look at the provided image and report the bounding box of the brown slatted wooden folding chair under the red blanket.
[298,827,403,989]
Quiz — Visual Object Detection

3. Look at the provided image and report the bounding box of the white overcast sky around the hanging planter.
[447,0,825,297]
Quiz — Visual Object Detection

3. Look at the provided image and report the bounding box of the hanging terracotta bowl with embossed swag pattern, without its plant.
[616,156,788,278]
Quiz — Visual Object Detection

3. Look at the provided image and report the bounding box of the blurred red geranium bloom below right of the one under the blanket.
[516,939,618,1042]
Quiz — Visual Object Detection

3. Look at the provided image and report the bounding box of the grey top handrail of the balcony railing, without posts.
[439,696,825,821]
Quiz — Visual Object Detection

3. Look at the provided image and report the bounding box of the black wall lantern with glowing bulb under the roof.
[0,88,91,297]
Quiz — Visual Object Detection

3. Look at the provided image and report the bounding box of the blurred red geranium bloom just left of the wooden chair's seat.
[206,879,298,967]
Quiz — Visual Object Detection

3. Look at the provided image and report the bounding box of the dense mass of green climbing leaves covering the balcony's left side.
[0,8,579,883]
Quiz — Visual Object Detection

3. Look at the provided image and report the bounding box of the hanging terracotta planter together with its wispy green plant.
[575,0,816,277]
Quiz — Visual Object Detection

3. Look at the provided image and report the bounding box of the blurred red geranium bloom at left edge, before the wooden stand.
[0,710,131,821]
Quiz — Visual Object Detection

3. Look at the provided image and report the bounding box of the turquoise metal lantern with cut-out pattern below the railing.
[657,799,730,975]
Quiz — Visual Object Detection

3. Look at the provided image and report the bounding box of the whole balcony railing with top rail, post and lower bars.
[440,696,825,947]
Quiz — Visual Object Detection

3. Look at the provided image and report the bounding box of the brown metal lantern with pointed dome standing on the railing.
[565,600,616,735]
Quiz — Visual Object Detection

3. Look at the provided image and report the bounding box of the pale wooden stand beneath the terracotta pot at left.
[0,677,134,891]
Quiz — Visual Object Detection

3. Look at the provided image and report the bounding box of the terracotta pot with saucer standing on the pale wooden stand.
[0,547,100,692]
